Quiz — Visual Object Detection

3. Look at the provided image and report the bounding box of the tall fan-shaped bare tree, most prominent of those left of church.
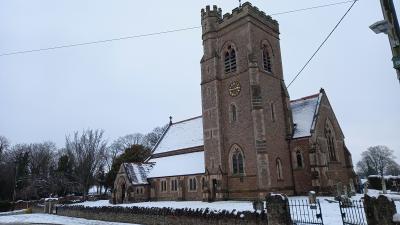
[65,129,107,197]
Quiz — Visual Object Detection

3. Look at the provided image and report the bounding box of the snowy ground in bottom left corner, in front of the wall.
[0,213,138,225]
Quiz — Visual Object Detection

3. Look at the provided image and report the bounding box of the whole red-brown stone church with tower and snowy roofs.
[112,2,356,203]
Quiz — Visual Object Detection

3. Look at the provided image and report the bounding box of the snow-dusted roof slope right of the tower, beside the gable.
[290,94,322,138]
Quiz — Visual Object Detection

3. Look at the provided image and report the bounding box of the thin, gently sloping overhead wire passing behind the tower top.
[0,0,358,57]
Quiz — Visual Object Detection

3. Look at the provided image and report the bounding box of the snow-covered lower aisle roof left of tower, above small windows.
[147,151,205,178]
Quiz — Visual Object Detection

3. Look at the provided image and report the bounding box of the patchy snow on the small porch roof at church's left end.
[124,163,153,185]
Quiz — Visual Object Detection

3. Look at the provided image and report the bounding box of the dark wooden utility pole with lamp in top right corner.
[370,0,400,82]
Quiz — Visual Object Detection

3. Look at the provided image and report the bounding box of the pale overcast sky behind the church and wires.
[0,0,400,161]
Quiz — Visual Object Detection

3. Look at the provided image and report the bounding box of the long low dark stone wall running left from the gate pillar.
[57,205,268,225]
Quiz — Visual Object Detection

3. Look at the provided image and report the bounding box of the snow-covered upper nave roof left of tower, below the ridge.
[153,116,204,154]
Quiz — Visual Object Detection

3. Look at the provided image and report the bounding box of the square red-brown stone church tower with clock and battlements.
[201,3,293,200]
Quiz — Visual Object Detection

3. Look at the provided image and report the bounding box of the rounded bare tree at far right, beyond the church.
[357,145,397,193]
